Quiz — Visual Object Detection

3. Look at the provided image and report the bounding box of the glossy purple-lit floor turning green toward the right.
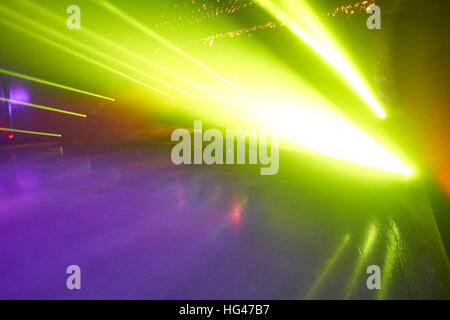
[0,144,445,299]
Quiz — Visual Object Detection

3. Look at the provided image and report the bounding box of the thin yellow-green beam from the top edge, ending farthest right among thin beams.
[94,0,247,95]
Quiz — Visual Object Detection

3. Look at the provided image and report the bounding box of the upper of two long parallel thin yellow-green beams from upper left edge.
[0,5,183,98]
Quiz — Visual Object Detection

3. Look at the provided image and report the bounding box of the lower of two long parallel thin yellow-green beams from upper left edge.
[0,17,176,100]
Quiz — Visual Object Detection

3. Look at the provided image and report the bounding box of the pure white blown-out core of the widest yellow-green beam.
[266,107,413,176]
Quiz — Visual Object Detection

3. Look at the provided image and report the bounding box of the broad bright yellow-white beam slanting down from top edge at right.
[258,0,386,118]
